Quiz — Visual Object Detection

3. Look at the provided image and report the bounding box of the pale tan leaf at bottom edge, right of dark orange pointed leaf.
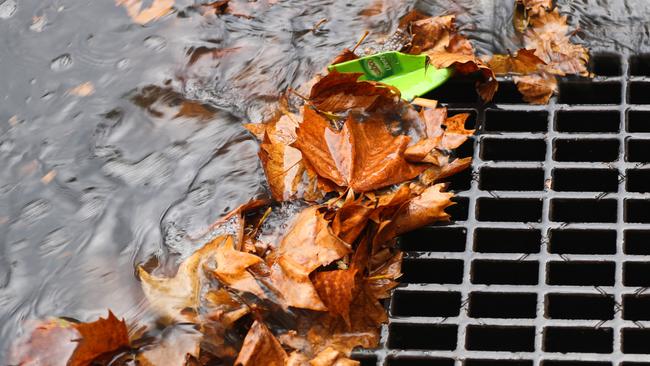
[136,325,202,366]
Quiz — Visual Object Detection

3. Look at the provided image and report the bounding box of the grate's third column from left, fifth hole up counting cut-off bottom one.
[549,229,616,254]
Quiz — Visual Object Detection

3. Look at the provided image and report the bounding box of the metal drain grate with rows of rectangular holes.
[356,54,650,366]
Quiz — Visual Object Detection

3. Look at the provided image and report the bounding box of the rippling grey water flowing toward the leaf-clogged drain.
[0,0,650,358]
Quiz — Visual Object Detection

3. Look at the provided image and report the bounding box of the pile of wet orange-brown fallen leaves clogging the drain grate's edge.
[10,1,586,366]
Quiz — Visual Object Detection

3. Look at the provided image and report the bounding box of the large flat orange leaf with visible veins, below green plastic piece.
[294,109,425,192]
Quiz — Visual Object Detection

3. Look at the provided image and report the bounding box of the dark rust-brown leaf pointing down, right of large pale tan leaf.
[313,268,358,326]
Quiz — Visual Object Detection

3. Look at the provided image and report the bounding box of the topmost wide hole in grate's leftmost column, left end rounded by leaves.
[399,226,467,252]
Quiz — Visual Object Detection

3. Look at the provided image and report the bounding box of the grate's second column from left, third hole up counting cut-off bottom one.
[469,292,537,319]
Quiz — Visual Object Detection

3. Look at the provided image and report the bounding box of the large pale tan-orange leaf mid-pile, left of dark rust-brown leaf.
[270,206,350,311]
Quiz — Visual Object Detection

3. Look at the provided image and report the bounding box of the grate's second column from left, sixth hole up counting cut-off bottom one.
[476,197,542,222]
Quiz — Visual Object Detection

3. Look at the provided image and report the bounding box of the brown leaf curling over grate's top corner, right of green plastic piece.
[427,52,499,102]
